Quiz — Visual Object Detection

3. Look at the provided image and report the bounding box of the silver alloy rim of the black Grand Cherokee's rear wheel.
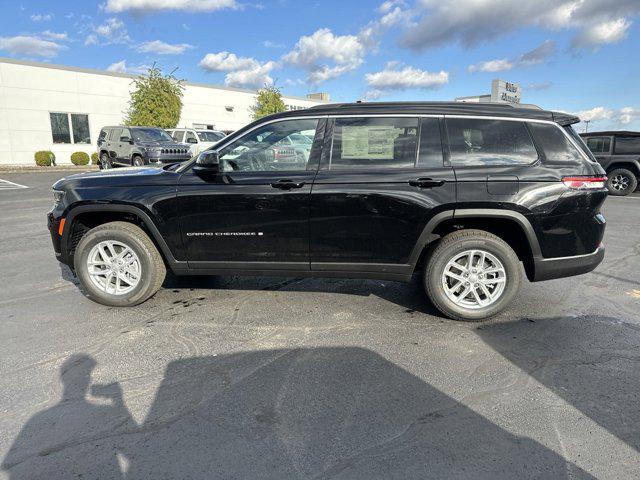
[442,250,507,310]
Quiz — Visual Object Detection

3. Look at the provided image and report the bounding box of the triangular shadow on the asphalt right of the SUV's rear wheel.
[476,316,640,451]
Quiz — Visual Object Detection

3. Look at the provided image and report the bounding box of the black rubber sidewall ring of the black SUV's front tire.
[74,228,155,306]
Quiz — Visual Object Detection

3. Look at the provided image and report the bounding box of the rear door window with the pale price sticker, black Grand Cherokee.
[329,117,418,170]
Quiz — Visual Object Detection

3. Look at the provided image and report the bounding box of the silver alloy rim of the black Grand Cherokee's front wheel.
[87,240,142,295]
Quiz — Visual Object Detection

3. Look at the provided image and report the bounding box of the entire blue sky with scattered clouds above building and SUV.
[0,0,640,131]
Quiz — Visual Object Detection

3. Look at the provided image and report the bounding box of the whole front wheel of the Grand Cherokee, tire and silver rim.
[74,222,166,307]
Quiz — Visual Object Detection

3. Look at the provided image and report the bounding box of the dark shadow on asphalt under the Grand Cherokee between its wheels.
[162,273,448,320]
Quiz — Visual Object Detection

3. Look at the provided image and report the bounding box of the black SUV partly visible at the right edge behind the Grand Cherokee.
[580,131,640,195]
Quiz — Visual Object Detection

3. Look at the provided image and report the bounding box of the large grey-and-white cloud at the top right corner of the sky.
[401,0,640,50]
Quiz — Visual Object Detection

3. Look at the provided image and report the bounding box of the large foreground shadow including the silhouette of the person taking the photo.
[2,347,593,480]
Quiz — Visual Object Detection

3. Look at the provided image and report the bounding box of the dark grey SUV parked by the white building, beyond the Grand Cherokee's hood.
[98,127,191,170]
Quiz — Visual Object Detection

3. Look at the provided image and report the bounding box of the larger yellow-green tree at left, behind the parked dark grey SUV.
[125,64,184,128]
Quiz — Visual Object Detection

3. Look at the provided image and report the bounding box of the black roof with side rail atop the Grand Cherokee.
[274,102,580,125]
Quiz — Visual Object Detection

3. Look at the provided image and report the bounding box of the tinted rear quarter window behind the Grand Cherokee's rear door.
[446,118,538,167]
